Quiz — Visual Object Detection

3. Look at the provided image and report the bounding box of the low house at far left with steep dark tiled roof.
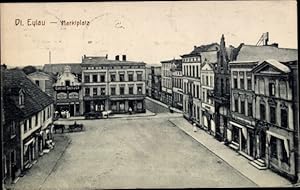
[3,69,53,183]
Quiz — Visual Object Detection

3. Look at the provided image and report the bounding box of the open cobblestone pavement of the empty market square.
[10,114,256,189]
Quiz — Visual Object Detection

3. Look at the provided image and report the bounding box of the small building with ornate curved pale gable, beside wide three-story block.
[52,66,83,116]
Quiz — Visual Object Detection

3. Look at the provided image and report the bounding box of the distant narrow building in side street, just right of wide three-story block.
[146,64,161,100]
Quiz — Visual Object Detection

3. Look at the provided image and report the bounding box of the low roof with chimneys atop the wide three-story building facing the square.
[81,56,145,66]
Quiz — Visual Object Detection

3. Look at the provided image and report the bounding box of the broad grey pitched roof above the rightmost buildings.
[236,45,298,62]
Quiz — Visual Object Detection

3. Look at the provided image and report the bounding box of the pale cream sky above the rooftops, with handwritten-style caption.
[0,0,297,66]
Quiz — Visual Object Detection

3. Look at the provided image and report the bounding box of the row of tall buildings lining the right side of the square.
[148,35,300,181]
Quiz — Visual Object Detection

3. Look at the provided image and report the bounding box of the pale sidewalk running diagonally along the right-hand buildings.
[169,118,292,187]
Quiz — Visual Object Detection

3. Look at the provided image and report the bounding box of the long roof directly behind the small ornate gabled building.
[43,63,81,75]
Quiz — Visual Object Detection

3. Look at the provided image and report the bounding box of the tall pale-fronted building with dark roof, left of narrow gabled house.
[181,43,219,126]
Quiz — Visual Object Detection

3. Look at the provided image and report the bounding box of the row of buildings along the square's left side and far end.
[1,55,146,188]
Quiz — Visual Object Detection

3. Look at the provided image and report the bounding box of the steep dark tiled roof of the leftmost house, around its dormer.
[3,69,53,120]
